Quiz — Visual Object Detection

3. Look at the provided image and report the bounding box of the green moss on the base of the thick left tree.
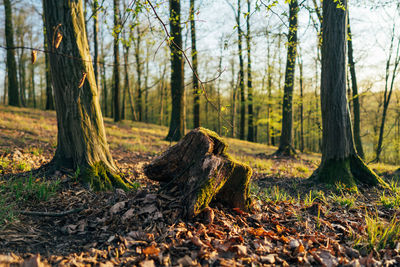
[79,162,131,191]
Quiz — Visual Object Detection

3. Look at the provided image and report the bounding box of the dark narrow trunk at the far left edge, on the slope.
[3,0,19,106]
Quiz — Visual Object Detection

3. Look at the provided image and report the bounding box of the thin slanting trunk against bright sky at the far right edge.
[375,24,400,162]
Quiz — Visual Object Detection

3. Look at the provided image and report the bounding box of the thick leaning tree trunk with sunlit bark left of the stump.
[44,0,128,189]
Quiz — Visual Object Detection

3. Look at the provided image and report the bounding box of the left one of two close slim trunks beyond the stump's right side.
[236,0,246,140]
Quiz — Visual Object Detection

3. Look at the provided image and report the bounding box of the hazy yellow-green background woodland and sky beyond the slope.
[0,0,400,164]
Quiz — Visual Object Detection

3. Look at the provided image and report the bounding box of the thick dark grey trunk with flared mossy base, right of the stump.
[312,0,384,187]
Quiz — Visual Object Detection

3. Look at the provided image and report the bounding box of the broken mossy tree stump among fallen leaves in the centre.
[144,128,252,218]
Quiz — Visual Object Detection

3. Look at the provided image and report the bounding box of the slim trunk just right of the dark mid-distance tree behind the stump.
[190,0,200,128]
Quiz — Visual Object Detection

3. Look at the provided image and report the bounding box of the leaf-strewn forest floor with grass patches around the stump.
[0,105,400,266]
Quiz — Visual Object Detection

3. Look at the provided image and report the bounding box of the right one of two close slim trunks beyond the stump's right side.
[246,0,254,142]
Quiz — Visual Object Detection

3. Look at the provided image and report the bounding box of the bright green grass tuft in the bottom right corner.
[355,214,400,252]
